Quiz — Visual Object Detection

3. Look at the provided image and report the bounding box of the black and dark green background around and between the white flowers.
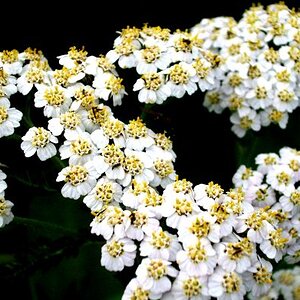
[0,0,299,300]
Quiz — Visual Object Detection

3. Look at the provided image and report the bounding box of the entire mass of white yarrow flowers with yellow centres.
[0,4,300,300]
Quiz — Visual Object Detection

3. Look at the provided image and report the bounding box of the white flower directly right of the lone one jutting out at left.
[59,132,97,165]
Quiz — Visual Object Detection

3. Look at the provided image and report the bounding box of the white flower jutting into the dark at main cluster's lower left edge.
[101,238,136,272]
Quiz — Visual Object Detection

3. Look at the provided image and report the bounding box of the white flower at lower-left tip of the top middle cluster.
[133,72,171,104]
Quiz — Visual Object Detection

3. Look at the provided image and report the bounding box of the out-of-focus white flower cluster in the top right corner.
[191,3,300,137]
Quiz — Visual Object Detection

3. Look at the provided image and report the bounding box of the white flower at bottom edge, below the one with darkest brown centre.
[208,267,246,300]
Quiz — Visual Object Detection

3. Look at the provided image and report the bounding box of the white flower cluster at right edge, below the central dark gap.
[233,147,300,263]
